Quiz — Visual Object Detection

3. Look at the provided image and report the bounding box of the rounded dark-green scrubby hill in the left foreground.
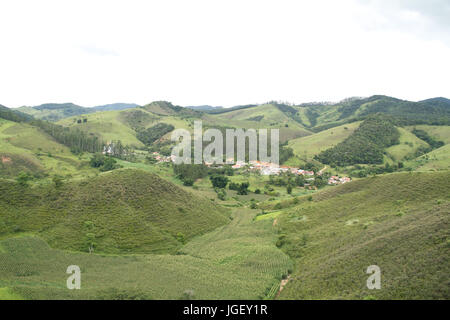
[0,169,229,253]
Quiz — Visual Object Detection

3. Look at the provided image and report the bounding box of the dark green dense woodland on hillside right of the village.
[314,115,400,166]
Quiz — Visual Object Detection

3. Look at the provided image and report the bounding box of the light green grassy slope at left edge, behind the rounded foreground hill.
[0,119,93,177]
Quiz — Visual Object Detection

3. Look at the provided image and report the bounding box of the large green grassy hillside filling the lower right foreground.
[278,171,450,299]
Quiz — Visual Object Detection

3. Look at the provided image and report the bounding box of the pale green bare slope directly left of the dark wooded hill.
[288,122,361,160]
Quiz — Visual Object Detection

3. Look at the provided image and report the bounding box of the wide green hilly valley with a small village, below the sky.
[0,96,450,300]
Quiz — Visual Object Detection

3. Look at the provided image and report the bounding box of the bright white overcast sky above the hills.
[0,0,450,107]
